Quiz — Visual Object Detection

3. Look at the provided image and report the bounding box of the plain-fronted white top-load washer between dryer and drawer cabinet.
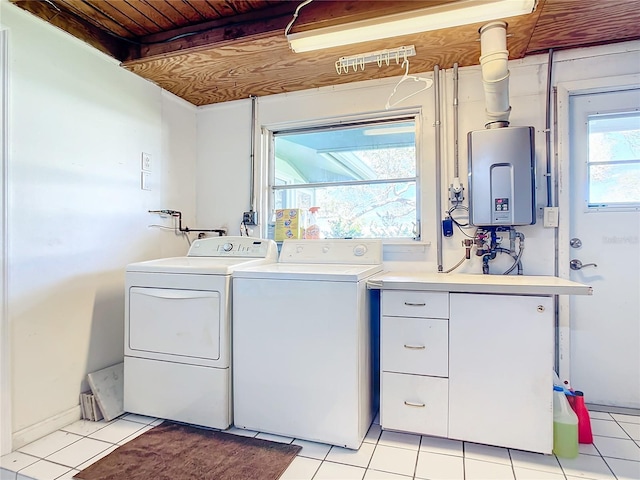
[233,240,382,449]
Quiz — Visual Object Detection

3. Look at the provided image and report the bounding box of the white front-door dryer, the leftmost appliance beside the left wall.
[124,237,277,429]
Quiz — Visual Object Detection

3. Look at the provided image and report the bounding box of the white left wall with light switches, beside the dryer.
[2,2,196,448]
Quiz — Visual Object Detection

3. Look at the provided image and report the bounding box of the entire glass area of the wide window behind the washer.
[271,118,418,238]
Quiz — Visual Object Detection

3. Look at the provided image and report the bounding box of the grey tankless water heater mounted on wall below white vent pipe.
[467,127,536,227]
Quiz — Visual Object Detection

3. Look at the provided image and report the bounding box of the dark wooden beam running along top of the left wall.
[9,0,130,60]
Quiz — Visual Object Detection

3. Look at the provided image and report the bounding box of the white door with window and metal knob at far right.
[565,88,640,408]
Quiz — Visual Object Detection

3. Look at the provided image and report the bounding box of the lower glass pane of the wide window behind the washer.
[275,181,416,238]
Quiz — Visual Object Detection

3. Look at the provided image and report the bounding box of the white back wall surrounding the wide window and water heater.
[197,42,640,275]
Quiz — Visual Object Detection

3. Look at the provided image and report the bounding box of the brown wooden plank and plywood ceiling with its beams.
[10,0,640,106]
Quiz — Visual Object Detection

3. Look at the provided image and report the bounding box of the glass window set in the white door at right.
[588,112,640,207]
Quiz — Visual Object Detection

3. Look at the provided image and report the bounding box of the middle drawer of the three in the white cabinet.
[380,317,449,377]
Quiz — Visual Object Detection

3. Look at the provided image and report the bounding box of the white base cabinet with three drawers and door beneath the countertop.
[380,290,554,453]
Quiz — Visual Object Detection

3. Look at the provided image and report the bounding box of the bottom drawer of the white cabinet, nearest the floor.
[380,372,449,437]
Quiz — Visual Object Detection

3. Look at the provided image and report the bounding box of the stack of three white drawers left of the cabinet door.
[380,291,449,436]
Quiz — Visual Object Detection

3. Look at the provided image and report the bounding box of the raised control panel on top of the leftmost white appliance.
[187,237,278,258]
